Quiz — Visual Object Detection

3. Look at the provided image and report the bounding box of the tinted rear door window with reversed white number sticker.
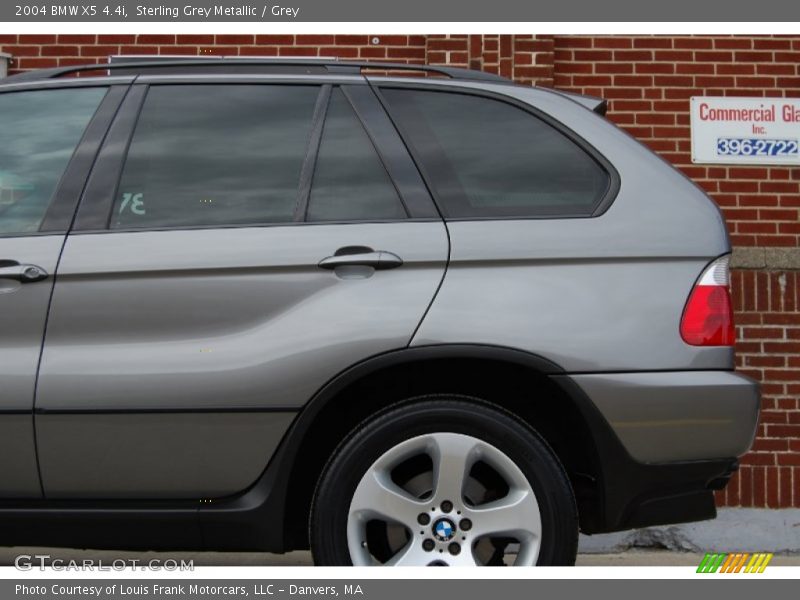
[111,85,319,227]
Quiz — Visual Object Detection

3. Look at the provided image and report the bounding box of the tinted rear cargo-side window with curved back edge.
[383,89,609,217]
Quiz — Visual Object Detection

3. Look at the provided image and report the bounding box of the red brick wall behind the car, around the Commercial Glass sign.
[0,34,800,507]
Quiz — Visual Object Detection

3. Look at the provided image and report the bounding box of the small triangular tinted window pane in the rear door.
[308,89,406,221]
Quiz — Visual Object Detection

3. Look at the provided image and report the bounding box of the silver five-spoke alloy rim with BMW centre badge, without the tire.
[347,432,542,565]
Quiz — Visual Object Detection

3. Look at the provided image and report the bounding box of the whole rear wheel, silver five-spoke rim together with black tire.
[310,398,577,566]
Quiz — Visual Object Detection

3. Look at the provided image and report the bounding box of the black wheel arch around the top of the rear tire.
[276,344,601,550]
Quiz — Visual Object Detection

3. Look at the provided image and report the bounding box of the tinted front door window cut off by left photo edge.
[0,88,106,233]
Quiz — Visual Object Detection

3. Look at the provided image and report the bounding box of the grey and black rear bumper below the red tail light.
[551,371,759,534]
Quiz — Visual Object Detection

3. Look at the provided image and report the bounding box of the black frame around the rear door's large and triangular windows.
[70,77,442,234]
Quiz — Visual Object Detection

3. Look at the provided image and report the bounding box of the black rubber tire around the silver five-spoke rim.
[309,396,578,565]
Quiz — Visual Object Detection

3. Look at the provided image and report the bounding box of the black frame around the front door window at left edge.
[0,81,123,239]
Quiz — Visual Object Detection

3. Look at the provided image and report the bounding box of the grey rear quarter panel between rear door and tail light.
[413,83,733,372]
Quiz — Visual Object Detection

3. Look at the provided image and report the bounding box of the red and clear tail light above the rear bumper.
[681,256,736,346]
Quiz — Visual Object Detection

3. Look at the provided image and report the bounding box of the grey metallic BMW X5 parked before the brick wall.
[0,59,759,565]
